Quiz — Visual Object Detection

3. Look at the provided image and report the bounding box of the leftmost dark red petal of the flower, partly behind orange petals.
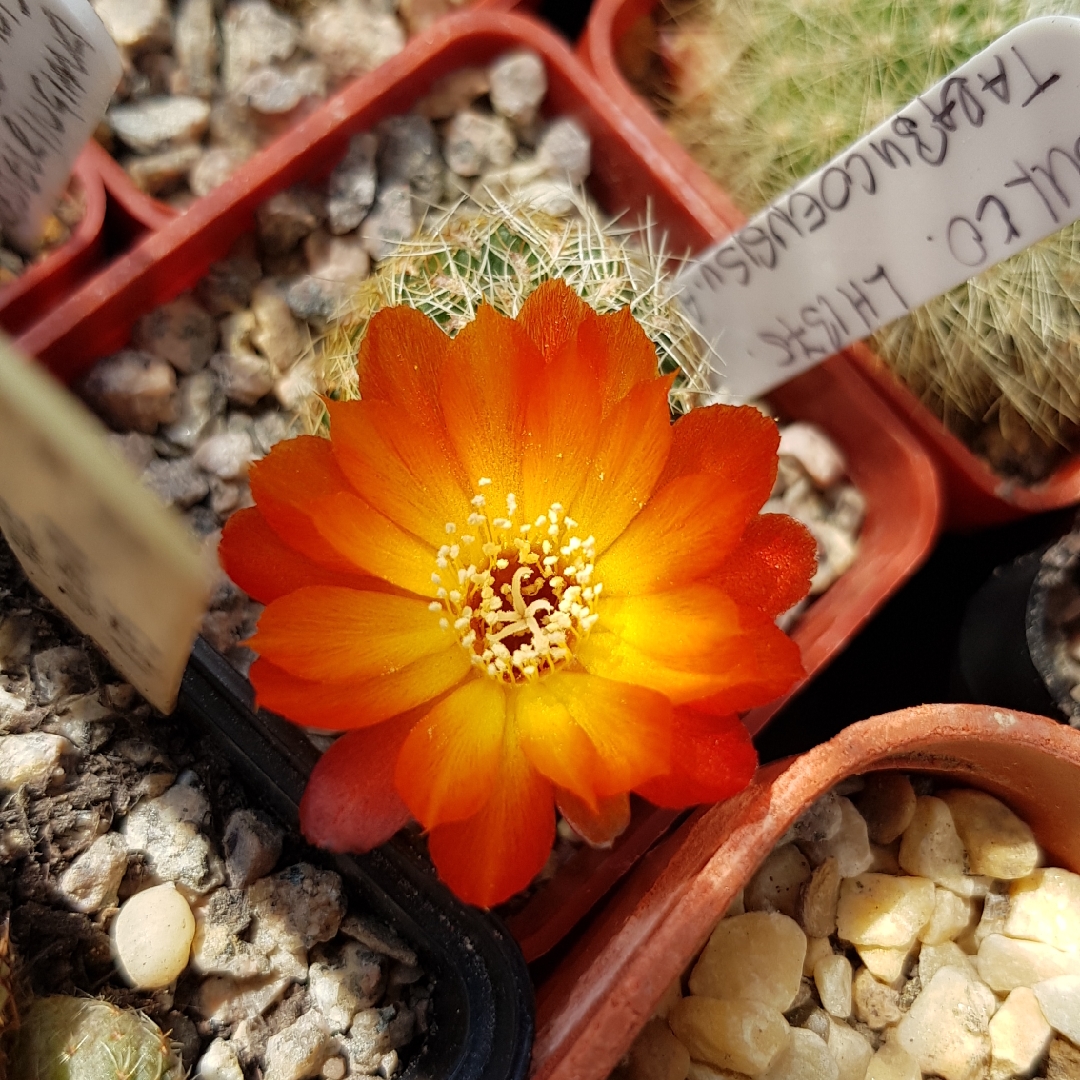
[217,507,375,604]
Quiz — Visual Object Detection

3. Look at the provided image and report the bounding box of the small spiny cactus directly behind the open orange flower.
[313,192,708,423]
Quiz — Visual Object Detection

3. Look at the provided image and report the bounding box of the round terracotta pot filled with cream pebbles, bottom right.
[531,705,1080,1080]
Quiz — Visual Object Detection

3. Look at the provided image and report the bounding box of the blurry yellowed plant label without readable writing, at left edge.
[0,337,212,713]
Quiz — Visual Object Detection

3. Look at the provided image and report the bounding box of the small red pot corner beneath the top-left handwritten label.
[0,144,105,334]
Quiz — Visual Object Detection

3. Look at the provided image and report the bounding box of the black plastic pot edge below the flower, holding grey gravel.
[178,638,534,1080]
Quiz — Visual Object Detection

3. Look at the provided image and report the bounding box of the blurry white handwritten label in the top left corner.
[0,0,123,252]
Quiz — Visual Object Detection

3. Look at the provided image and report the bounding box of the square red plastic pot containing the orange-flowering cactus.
[19,12,939,959]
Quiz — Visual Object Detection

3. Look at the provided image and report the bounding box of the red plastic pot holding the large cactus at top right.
[578,0,1080,529]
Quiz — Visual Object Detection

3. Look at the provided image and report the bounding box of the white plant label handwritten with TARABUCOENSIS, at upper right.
[679,16,1080,399]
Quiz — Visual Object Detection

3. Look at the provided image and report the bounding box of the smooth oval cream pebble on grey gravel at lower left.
[112,881,195,990]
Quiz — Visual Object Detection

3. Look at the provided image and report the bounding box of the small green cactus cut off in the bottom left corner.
[9,997,184,1080]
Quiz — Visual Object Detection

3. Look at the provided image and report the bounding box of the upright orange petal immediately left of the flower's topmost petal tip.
[440,305,535,503]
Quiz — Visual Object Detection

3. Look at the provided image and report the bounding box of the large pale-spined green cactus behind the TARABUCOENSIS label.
[669,0,1080,478]
